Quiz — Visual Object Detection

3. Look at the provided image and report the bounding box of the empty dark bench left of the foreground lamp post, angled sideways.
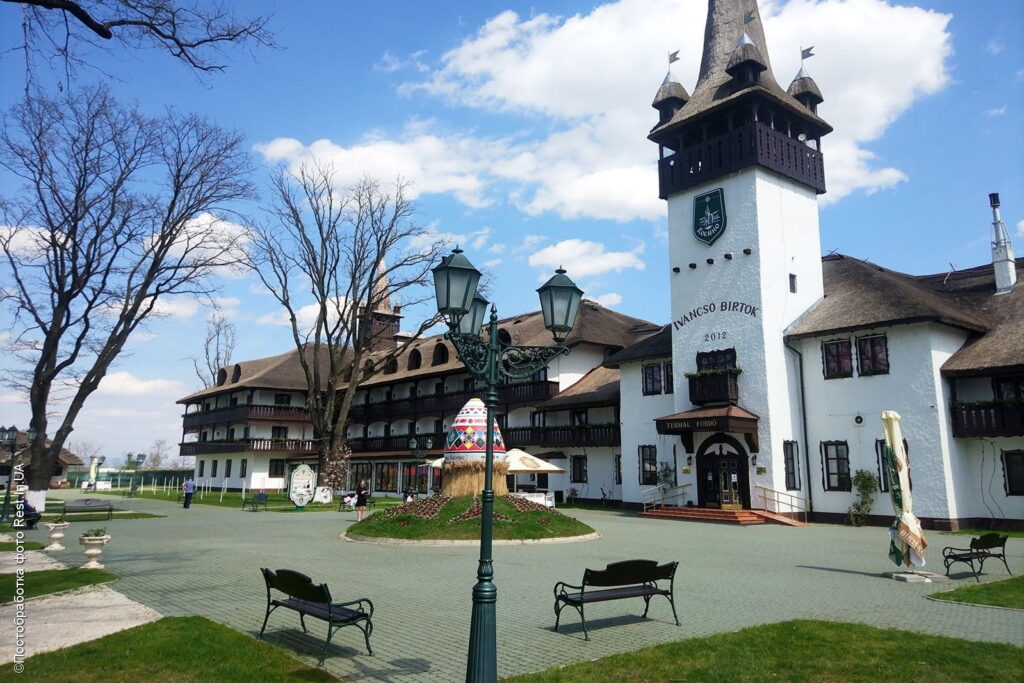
[259,568,374,666]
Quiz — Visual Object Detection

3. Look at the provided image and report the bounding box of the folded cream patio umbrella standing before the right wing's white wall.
[882,411,928,567]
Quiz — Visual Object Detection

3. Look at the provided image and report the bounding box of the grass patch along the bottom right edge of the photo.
[507,621,1024,683]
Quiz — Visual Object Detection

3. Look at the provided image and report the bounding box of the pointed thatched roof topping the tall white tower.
[649,0,831,138]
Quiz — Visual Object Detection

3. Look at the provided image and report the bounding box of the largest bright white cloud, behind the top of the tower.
[256,0,952,220]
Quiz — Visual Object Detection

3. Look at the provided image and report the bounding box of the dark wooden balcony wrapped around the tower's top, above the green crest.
[657,122,825,200]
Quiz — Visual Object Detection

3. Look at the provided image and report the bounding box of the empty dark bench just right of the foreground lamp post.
[555,560,679,640]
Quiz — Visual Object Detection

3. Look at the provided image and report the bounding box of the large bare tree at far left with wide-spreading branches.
[0,88,252,504]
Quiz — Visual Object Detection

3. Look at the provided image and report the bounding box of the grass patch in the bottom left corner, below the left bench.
[0,616,336,683]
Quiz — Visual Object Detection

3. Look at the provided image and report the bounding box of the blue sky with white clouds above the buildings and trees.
[0,0,1024,459]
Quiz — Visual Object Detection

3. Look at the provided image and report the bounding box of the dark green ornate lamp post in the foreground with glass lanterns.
[433,248,583,683]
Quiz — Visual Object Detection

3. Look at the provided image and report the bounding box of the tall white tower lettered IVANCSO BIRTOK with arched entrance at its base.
[649,0,831,508]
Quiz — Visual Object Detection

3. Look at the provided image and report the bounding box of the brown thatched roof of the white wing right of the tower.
[787,254,1024,375]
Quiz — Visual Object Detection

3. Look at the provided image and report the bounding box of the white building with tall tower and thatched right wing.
[606,0,1024,527]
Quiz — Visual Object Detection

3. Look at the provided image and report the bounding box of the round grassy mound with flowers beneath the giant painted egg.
[348,496,594,540]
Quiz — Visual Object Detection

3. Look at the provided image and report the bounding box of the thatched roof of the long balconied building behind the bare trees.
[177,300,657,403]
